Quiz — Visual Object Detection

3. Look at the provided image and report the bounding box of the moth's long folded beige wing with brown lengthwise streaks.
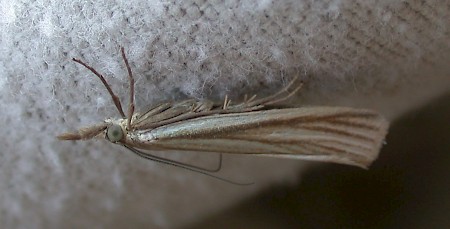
[134,107,388,168]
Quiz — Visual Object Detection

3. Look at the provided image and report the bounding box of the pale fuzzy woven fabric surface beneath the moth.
[0,0,450,228]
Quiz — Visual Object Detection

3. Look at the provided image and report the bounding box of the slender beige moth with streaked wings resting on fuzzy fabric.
[58,47,389,181]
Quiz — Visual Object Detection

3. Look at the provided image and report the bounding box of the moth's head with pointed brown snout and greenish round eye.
[57,120,125,143]
